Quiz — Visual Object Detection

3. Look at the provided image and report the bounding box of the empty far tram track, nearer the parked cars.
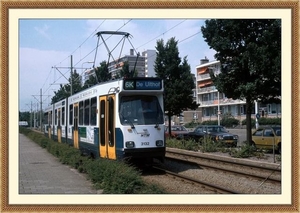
[166,149,281,184]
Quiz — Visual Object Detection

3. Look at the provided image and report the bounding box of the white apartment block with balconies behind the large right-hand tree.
[196,58,281,121]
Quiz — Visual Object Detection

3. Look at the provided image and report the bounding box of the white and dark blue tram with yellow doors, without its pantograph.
[44,78,165,161]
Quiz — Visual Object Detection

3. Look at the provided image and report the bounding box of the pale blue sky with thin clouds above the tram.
[19,19,215,112]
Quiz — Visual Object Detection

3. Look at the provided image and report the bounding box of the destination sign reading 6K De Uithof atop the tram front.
[124,78,162,90]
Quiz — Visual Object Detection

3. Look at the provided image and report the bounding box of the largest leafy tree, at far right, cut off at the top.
[201,19,281,143]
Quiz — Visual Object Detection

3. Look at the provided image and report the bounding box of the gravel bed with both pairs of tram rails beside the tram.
[143,148,282,194]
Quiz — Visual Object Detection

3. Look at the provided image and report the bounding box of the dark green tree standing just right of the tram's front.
[154,37,198,136]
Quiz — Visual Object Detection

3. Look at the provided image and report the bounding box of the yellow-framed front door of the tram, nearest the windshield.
[99,95,116,159]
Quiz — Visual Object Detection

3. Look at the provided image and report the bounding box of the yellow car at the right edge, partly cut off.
[252,126,281,153]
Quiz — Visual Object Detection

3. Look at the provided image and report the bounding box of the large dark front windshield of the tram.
[119,95,164,126]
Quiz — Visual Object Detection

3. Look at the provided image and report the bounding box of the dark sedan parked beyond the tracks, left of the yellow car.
[184,125,239,147]
